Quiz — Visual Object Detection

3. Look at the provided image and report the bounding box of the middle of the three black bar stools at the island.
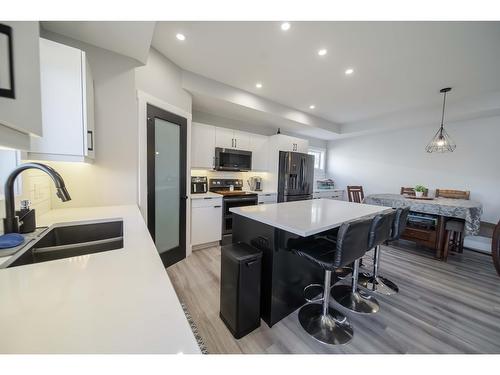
[332,216,379,314]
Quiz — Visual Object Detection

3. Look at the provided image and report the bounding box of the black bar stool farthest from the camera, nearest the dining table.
[358,212,398,295]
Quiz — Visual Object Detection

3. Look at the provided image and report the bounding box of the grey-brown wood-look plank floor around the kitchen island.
[167,241,500,354]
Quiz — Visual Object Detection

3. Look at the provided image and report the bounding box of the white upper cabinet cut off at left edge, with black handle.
[0,21,42,150]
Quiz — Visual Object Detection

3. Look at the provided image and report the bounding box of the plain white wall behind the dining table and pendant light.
[328,117,500,223]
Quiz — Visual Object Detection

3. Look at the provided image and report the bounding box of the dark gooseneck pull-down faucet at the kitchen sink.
[3,163,71,233]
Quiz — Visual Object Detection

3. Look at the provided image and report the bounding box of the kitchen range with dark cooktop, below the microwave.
[209,178,258,245]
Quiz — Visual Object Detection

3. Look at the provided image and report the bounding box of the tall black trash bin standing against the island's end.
[219,243,262,339]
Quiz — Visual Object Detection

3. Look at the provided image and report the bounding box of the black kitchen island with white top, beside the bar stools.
[231,199,391,327]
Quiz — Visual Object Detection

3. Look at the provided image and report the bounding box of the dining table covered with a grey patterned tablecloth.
[363,194,483,258]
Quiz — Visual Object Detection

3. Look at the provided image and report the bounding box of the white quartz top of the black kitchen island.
[230,199,391,237]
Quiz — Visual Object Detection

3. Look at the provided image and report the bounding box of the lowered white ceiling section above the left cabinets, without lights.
[42,21,156,64]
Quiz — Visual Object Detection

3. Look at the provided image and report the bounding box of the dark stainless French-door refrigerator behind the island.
[278,151,314,202]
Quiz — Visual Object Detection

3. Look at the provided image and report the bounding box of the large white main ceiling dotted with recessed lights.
[152,22,500,124]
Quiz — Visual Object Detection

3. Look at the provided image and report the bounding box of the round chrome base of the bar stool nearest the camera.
[299,303,354,345]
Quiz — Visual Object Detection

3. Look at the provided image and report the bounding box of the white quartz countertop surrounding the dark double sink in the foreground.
[0,206,200,353]
